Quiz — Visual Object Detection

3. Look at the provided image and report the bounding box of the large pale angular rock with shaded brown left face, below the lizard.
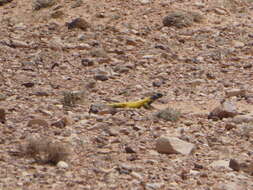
[156,136,195,155]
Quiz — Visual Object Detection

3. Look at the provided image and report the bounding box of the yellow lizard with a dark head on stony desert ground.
[107,93,163,109]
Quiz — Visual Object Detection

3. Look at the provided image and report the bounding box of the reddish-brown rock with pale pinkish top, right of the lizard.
[208,101,238,119]
